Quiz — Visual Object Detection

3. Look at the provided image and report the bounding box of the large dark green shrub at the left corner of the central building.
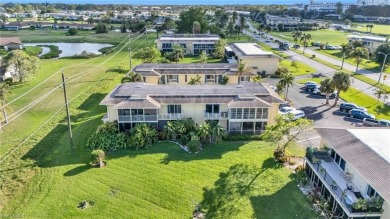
[87,123,129,151]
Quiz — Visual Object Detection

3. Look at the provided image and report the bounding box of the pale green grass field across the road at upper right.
[268,29,350,45]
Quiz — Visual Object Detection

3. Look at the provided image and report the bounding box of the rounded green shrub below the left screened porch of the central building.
[129,124,158,149]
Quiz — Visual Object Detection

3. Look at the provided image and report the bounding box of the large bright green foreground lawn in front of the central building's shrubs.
[4,139,316,218]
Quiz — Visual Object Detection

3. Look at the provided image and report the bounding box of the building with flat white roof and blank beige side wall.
[225,43,280,76]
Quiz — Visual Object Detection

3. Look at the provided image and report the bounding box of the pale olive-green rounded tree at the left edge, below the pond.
[4,50,39,82]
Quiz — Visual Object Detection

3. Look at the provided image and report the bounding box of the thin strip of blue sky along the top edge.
[5,0,357,5]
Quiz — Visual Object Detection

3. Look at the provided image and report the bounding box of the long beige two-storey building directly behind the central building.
[133,63,257,85]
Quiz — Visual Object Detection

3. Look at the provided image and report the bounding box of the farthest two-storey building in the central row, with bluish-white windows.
[156,34,220,55]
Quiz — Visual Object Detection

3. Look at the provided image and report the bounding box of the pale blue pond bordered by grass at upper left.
[24,43,114,58]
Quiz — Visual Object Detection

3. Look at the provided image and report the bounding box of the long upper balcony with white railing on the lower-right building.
[306,157,382,216]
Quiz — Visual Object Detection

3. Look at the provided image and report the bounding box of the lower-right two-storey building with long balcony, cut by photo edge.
[305,128,390,219]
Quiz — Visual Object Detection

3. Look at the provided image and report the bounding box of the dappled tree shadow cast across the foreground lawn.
[200,158,281,218]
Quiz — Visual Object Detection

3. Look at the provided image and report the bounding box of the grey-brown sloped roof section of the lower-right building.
[316,128,390,202]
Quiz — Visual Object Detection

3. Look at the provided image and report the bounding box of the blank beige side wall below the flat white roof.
[238,56,279,75]
